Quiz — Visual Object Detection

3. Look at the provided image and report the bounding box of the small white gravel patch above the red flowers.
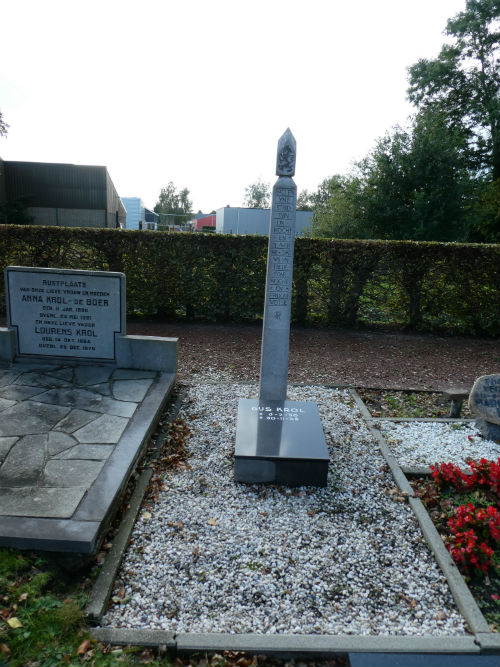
[379,421,500,470]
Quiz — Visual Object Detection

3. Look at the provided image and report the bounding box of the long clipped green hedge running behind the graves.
[0,225,500,336]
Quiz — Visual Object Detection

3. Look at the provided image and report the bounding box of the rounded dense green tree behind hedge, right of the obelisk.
[313,110,470,241]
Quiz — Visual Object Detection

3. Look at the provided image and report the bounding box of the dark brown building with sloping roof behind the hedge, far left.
[0,160,126,229]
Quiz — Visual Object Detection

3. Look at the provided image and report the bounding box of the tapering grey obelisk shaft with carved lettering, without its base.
[259,129,297,401]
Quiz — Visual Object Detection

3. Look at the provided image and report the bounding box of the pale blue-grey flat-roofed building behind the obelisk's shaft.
[215,206,312,236]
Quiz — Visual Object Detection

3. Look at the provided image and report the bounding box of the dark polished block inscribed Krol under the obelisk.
[234,398,330,486]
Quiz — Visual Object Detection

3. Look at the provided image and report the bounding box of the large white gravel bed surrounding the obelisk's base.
[103,384,466,635]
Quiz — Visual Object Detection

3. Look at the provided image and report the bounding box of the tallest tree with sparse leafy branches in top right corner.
[408,0,500,181]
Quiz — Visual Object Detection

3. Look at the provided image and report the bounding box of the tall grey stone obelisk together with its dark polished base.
[234,130,329,486]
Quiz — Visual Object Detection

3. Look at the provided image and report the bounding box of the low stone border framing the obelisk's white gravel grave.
[86,384,500,667]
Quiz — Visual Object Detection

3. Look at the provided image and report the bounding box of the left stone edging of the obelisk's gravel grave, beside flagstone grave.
[85,468,153,623]
